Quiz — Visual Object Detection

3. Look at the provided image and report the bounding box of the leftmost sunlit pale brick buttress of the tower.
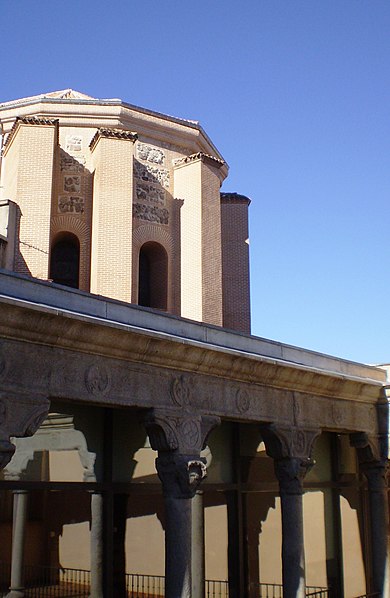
[5,123,57,279]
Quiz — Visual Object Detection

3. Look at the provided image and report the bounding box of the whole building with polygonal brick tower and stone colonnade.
[0,89,390,598]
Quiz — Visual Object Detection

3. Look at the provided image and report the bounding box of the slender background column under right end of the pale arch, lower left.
[90,492,104,598]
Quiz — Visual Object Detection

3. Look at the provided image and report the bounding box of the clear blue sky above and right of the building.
[0,0,390,363]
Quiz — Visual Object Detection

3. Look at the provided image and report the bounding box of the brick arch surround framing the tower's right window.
[132,224,177,313]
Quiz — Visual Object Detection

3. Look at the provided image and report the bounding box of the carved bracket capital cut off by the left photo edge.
[0,393,50,469]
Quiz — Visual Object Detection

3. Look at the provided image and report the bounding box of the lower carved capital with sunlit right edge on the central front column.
[156,453,207,498]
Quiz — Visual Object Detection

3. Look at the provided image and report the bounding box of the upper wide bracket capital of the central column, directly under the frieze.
[144,409,220,455]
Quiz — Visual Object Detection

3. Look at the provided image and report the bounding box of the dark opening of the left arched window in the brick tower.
[50,233,80,289]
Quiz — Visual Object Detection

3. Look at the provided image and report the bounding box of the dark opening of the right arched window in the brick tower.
[138,241,168,310]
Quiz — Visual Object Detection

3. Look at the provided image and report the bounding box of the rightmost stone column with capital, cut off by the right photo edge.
[351,434,390,598]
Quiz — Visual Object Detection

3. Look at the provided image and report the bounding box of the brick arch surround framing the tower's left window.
[51,214,91,291]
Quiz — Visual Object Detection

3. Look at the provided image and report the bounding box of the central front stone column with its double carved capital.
[145,400,219,598]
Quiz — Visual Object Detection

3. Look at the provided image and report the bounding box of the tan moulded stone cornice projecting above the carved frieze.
[0,289,383,408]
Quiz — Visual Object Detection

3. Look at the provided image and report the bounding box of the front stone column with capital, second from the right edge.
[262,425,319,598]
